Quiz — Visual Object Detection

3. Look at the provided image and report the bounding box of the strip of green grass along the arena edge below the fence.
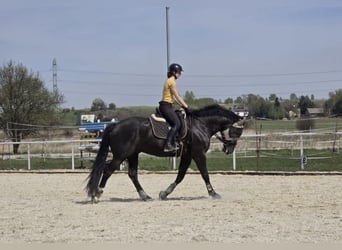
[0,149,342,171]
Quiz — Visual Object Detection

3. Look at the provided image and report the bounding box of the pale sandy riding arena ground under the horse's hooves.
[0,173,342,243]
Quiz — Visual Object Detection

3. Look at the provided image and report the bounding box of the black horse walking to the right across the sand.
[86,104,244,202]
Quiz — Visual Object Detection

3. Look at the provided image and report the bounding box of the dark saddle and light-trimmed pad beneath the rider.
[149,108,188,140]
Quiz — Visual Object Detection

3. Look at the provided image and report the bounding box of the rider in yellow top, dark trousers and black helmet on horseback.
[159,63,188,152]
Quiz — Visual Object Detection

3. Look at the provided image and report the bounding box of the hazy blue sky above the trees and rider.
[0,0,342,108]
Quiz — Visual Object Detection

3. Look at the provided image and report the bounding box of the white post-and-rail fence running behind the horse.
[0,132,342,170]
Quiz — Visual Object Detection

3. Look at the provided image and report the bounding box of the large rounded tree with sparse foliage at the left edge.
[0,61,63,154]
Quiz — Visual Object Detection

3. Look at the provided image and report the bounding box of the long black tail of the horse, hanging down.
[86,125,114,197]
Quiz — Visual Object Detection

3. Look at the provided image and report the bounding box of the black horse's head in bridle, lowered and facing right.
[216,118,246,154]
